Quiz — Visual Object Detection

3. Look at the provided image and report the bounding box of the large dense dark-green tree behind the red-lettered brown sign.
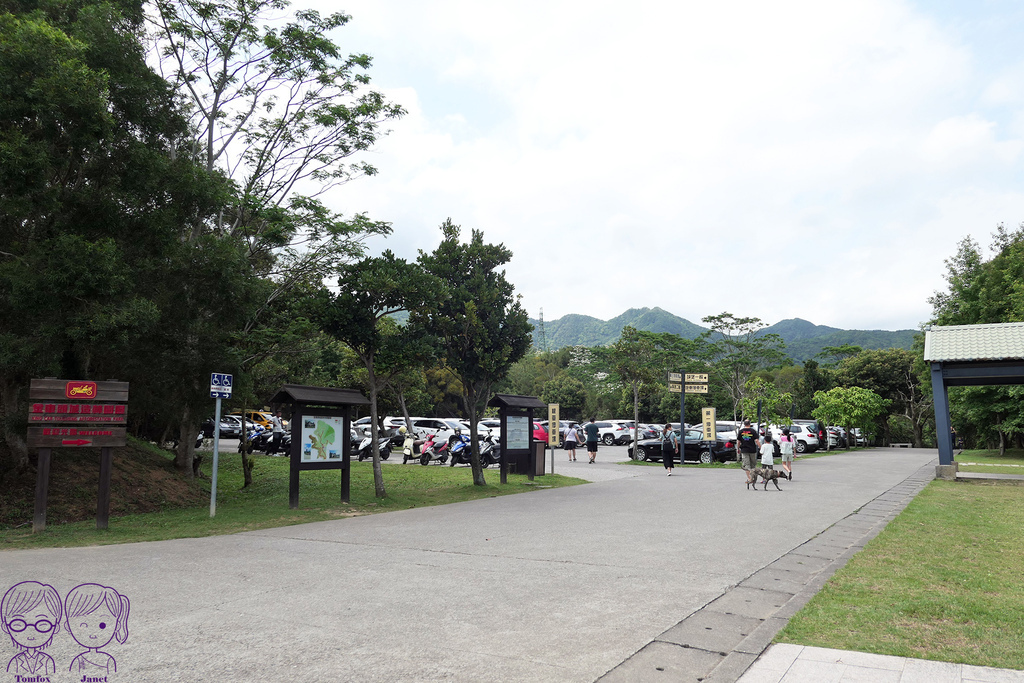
[0,1,226,471]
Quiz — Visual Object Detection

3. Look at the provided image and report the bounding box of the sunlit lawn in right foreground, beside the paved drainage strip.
[775,481,1024,669]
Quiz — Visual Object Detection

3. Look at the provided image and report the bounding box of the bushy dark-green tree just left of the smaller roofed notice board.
[410,219,532,486]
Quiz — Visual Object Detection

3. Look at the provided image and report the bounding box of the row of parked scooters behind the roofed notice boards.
[239,425,501,467]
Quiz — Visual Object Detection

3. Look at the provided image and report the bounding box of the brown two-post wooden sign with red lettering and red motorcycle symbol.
[28,378,128,532]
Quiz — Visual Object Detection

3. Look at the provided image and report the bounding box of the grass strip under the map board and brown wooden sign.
[0,452,585,550]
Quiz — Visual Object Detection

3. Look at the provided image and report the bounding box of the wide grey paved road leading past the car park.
[0,449,935,683]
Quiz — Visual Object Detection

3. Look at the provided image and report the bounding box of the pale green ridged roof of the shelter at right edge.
[925,323,1024,362]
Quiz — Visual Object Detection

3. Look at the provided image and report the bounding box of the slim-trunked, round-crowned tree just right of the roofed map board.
[319,251,444,498]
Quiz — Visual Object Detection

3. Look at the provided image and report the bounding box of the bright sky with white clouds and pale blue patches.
[293,0,1024,330]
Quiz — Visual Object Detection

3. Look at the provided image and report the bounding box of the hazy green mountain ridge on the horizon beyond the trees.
[529,307,918,362]
